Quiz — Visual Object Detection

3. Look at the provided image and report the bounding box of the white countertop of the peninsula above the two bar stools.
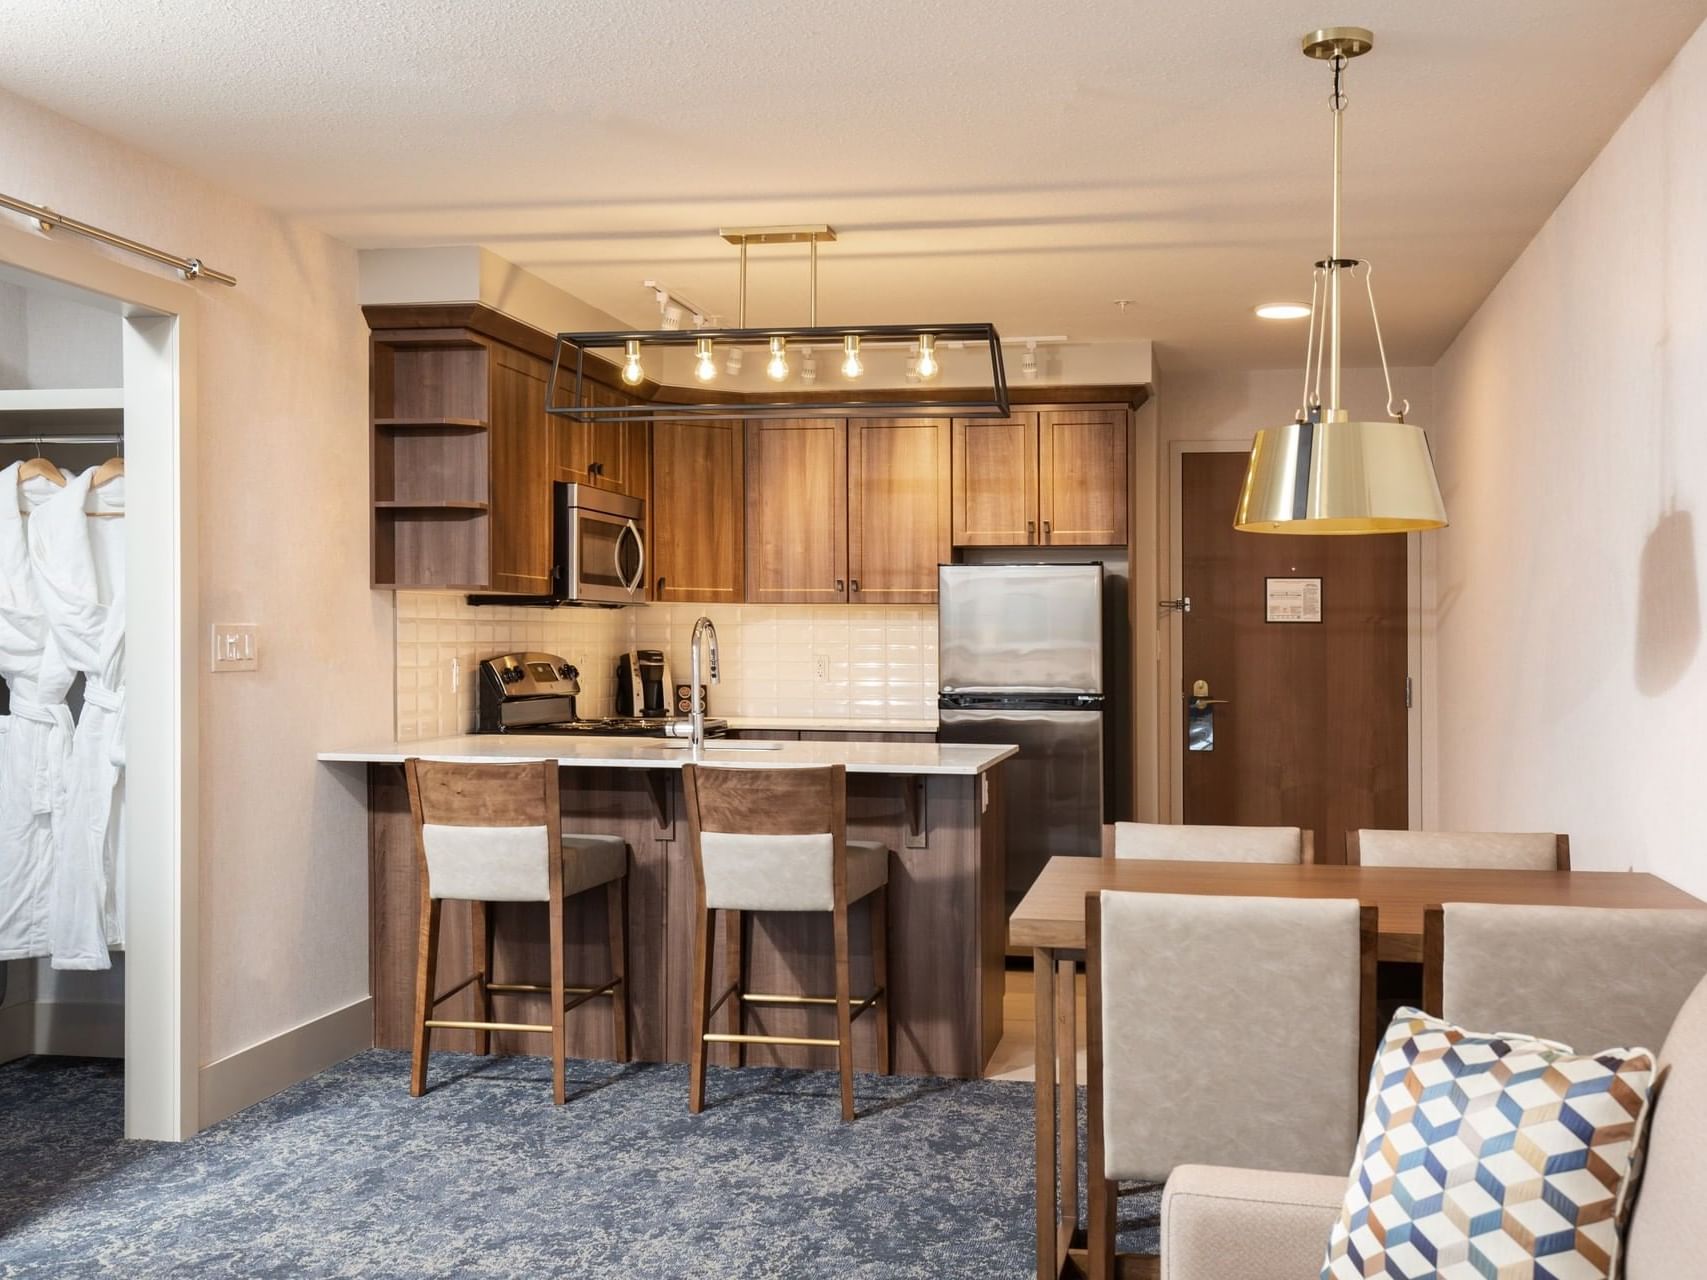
[318,734,1019,775]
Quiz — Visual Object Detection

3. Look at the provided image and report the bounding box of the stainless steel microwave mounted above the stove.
[468,483,647,608]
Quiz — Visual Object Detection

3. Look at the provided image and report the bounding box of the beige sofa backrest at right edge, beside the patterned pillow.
[1625,981,1707,1280]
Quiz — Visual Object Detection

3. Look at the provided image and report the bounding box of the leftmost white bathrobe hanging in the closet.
[0,463,72,959]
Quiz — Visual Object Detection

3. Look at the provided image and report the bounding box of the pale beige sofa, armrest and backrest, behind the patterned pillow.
[1162,976,1707,1280]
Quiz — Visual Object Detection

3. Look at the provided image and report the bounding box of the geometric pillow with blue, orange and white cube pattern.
[1321,1009,1652,1280]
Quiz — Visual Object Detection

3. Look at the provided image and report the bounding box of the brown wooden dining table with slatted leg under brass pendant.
[1007,855,1704,1280]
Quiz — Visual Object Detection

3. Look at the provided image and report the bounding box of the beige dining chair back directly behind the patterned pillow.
[1422,903,1707,1051]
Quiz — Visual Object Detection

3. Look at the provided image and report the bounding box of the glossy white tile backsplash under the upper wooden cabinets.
[396,591,937,742]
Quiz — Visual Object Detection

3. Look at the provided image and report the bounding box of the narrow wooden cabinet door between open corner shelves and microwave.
[488,346,551,594]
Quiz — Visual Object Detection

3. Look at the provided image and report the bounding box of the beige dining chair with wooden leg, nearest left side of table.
[1086,893,1376,1280]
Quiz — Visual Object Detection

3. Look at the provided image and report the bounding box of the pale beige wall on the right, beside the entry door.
[1436,20,1707,894]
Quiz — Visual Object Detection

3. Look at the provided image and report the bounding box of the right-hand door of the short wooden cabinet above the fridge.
[1038,408,1127,546]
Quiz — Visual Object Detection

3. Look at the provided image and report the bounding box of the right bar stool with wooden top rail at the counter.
[683,765,891,1120]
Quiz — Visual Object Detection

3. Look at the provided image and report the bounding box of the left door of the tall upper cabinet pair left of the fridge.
[746,418,848,604]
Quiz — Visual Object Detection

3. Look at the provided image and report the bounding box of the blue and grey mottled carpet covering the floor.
[0,1050,1157,1280]
